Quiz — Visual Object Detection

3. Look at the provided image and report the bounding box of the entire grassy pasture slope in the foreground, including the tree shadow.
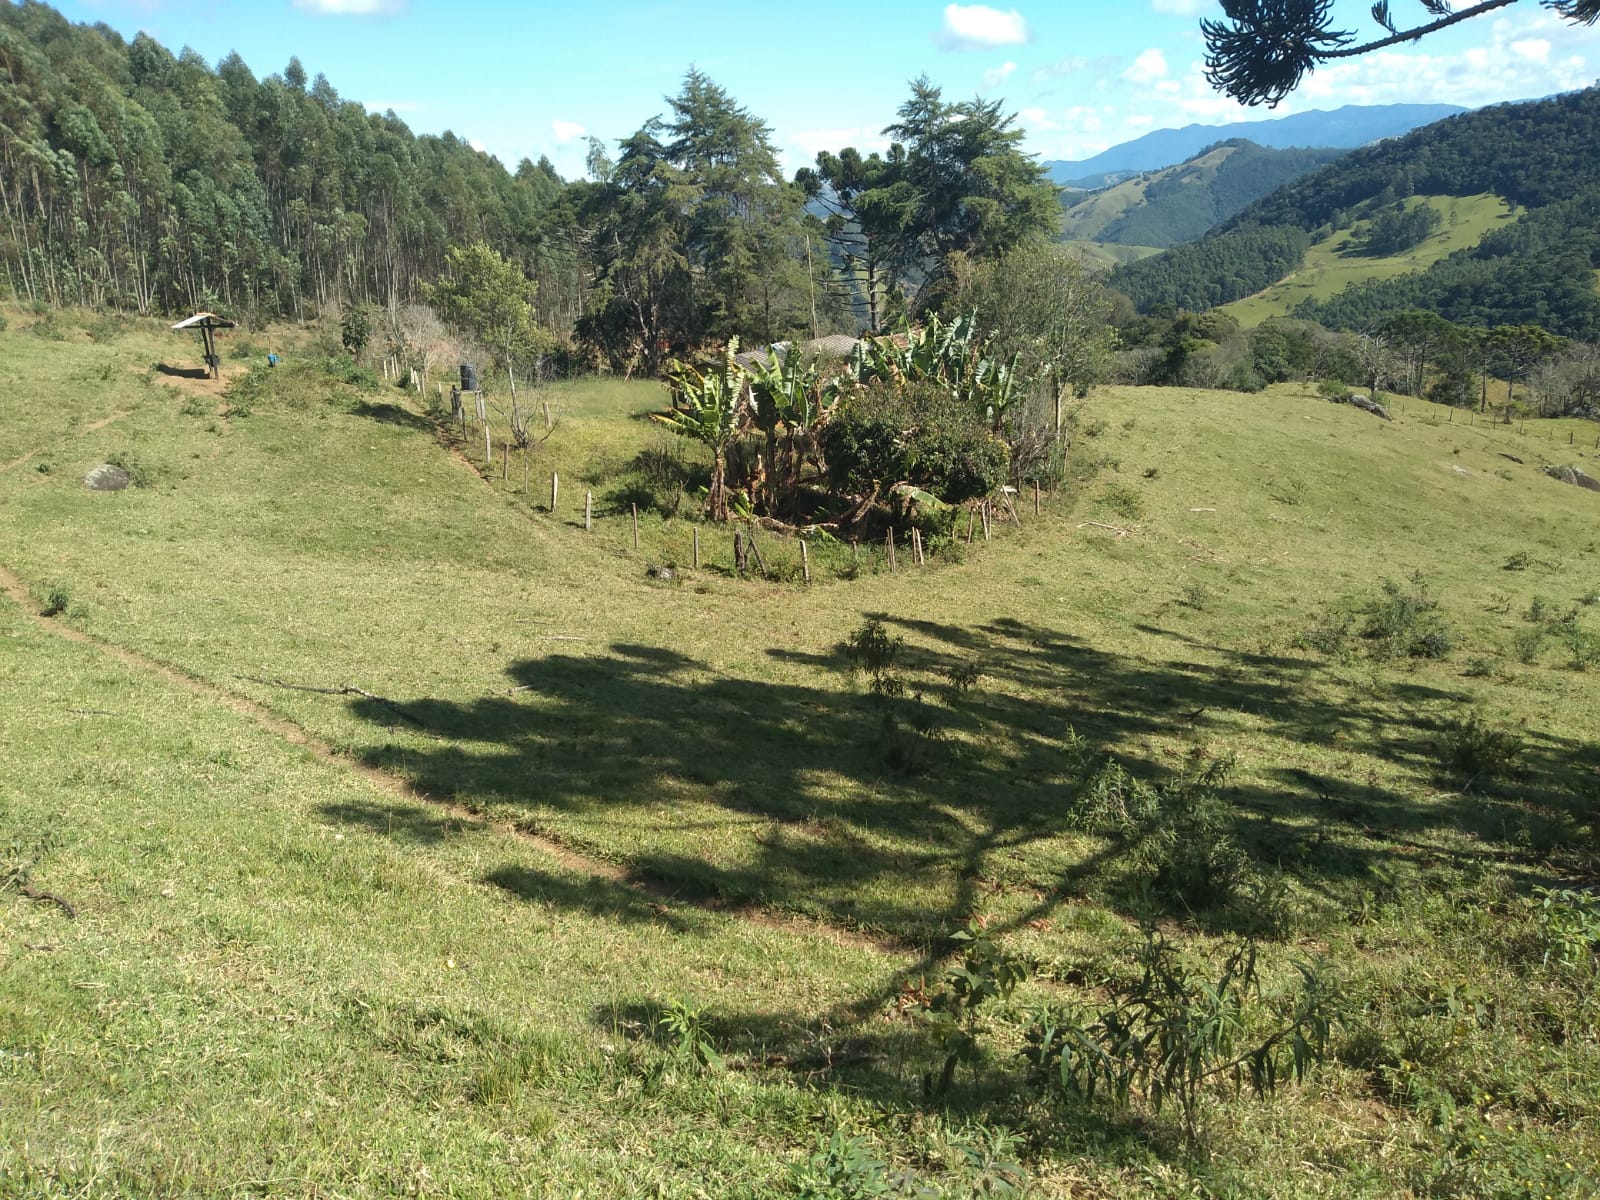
[0,314,1600,1197]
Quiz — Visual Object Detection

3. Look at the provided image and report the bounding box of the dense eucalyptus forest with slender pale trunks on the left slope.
[0,3,576,325]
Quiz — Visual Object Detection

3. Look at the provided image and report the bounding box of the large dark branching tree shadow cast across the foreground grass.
[318,616,1594,1177]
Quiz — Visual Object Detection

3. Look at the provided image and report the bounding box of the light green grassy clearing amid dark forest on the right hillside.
[1222,194,1520,328]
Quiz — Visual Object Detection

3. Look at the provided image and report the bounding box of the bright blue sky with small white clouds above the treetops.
[43,0,1600,176]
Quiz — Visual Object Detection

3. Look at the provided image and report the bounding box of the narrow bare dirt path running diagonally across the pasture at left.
[0,565,912,957]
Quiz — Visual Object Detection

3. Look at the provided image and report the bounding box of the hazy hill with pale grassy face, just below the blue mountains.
[1062,138,1344,246]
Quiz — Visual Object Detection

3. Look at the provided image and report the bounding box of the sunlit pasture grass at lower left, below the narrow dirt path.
[0,603,934,1197]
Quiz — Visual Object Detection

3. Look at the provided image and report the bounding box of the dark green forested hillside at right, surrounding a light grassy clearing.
[1114,88,1600,339]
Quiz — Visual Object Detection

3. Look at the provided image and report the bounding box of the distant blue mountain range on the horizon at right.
[1045,104,1466,189]
